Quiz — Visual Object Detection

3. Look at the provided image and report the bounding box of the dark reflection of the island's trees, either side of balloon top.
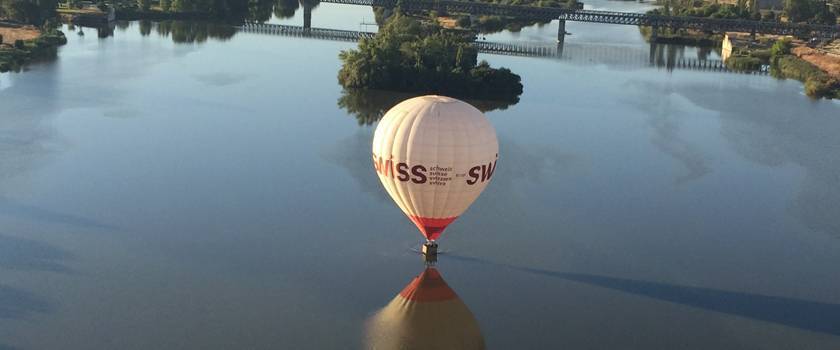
[338,90,518,125]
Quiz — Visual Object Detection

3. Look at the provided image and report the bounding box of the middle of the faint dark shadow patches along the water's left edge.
[0,235,72,273]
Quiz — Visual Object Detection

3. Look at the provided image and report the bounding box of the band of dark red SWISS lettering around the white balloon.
[373,153,499,186]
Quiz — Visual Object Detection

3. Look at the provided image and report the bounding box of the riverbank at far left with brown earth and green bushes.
[0,26,67,73]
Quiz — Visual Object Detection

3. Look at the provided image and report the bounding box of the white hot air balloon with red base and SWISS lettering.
[373,96,499,252]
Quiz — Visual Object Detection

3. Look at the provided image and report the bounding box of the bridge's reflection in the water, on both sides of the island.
[238,23,766,74]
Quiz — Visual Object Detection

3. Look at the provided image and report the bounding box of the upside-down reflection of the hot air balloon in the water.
[365,267,484,350]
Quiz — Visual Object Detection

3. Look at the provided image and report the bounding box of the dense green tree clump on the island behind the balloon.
[338,11,522,103]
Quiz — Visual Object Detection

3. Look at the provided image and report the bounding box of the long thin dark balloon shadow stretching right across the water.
[450,255,840,335]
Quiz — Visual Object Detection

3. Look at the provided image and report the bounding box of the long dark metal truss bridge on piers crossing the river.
[321,0,840,40]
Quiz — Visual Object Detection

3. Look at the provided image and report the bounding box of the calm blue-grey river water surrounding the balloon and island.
[0,2,840,349]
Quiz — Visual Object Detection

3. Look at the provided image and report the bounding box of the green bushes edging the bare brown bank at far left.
[0,27,67,73]
